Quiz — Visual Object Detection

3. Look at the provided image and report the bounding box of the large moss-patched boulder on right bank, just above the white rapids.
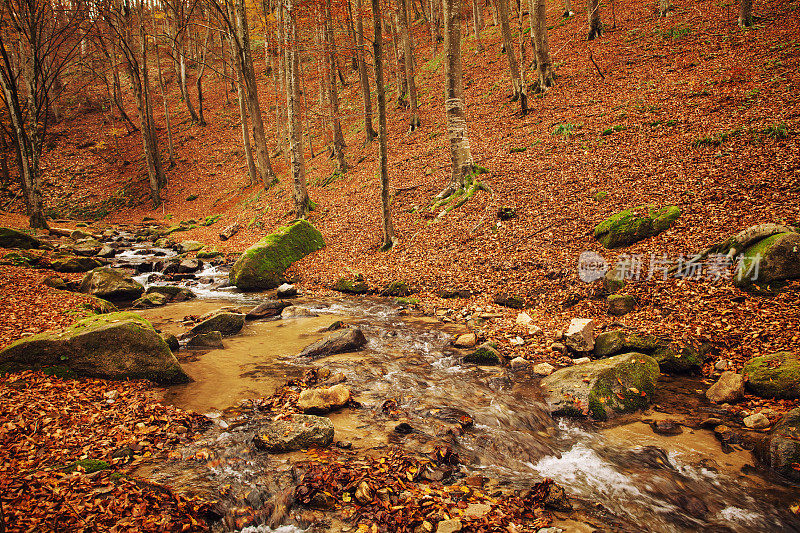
[541,353,659,420]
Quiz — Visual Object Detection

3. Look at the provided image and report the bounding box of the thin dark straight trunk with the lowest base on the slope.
[372,0,396,250]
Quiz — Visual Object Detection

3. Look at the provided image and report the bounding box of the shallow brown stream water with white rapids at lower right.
[109,241,800,532]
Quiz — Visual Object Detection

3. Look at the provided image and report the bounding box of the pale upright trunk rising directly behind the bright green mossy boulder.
[283,0,310,218]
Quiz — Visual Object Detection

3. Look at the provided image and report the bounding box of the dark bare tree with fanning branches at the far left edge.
[0,0,90,224]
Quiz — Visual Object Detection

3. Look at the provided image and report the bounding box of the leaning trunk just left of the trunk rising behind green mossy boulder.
[236,0,278,189]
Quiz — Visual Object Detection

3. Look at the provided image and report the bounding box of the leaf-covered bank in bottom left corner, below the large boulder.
[0,372,208,533]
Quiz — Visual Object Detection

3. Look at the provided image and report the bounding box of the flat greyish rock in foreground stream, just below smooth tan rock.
[253,415,333,453]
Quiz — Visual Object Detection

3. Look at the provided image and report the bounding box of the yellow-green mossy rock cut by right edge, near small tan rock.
[742,352,800,398]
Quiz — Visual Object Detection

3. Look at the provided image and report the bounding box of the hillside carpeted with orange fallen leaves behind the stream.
[0,0,800,524]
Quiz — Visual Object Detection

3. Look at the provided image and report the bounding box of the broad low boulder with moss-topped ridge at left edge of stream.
[0,312,191,383]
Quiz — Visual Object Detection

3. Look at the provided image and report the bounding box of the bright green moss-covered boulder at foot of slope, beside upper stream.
[230,220,325,289]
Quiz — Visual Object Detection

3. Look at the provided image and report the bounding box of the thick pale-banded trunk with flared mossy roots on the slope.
[437,0,475,198]
